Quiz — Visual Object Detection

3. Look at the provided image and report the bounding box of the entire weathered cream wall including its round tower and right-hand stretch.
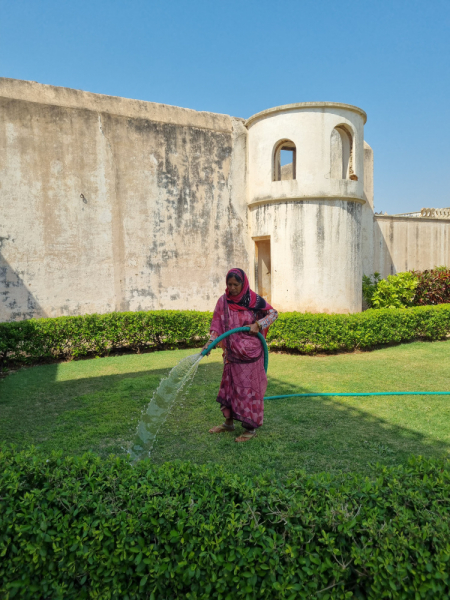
[0,79,450,321]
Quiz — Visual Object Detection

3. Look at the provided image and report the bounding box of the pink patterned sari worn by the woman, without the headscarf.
[211,294,267,429]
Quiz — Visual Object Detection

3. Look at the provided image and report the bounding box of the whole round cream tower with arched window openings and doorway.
[246,102,366,313]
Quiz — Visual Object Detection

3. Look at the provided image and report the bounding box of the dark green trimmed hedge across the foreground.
[0,449,450,600]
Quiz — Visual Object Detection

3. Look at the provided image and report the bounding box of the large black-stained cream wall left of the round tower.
[0,79,249,320]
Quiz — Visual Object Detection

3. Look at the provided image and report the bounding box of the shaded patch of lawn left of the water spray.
[0,364,169,455]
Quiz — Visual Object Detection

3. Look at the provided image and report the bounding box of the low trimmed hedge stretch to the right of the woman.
[267,304,450,354]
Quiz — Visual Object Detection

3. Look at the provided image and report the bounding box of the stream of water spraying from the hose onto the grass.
[128,354,203,463]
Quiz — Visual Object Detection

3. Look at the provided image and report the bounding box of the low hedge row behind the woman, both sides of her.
[0,304,450,363]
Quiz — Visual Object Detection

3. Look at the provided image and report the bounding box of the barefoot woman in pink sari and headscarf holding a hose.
[205,269,278,442]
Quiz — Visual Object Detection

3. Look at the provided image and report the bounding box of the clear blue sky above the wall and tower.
[0,0,450,213]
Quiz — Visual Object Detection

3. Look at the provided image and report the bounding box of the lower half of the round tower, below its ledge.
[250,199,362,313]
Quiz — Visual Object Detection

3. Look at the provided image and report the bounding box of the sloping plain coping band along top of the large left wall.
[0,77,239,133]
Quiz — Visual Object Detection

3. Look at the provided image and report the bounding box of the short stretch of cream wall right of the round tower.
[367,215,450,277]
